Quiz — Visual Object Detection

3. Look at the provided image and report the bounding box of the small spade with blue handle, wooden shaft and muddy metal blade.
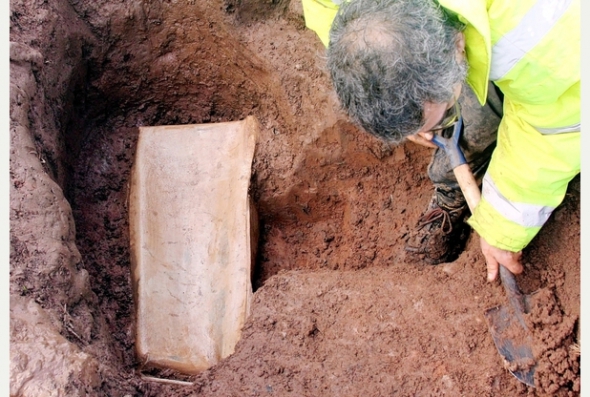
[432,117,536,387]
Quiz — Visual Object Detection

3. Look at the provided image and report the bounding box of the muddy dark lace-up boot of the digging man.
[405,188,471,265]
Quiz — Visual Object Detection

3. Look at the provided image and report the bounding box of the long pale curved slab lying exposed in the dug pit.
[129,116,259,374]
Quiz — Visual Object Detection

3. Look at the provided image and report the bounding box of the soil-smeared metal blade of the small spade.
[485,306,536,387]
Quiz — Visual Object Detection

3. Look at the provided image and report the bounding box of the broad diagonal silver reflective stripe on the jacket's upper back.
[490,0,572,81]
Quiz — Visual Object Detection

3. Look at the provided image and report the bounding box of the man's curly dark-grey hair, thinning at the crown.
[327,0,467,144]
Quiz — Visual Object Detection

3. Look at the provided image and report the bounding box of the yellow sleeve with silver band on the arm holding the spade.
[468,101,581,252]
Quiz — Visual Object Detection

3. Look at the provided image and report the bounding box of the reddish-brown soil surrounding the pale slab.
[10,0,580,397]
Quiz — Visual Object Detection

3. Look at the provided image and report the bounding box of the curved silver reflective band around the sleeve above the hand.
[482,173,555,227]
